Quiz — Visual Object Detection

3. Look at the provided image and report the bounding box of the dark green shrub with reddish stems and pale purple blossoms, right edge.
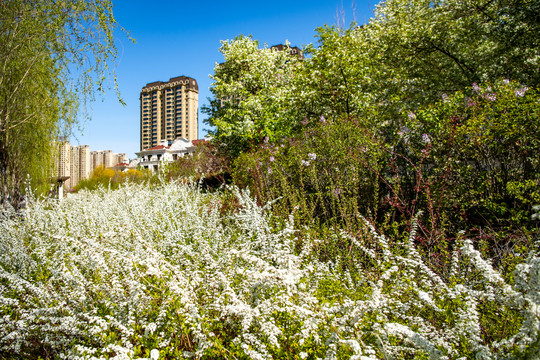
[386,80,540,266]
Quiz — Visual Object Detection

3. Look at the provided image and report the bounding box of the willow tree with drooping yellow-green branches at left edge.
[0,0,127,205]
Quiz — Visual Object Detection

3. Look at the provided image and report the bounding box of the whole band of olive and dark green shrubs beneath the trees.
[233,81,540,273]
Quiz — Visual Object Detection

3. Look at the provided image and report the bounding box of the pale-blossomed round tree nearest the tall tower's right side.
[204,36,301,154]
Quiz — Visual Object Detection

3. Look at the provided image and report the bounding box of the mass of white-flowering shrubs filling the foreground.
[0,184,540,360]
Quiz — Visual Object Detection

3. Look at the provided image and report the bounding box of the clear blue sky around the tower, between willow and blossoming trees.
[71,0,376,158]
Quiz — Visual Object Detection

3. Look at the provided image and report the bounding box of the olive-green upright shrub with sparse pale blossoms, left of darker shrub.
[233,117,388,229]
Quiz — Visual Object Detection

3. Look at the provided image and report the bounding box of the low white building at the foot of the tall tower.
[136,138,204,172]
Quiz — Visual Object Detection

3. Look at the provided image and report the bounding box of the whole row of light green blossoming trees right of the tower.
[207,0,540,154]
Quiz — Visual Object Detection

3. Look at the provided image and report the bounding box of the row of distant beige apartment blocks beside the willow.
[53,140,127,189]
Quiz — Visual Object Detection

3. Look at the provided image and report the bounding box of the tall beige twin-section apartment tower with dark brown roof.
[140,76,199,150]
